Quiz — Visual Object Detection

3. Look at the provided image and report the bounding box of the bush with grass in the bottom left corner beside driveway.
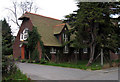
[2,56,28,81]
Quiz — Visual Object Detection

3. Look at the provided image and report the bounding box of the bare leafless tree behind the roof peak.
[6,0,38,27]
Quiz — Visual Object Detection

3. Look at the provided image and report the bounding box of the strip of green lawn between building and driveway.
[23,60,118,70]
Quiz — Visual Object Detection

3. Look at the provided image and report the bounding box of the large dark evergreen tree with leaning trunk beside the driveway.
[66,2,119,66]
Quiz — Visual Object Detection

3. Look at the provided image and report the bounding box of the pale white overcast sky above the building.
[0,0,78,36]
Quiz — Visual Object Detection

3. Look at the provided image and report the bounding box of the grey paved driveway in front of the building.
[17,63,118,80]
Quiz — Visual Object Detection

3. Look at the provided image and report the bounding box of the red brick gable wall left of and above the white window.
[13,20,33,58]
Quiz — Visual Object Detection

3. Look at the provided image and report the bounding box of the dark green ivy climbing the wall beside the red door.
[27,27,44,61]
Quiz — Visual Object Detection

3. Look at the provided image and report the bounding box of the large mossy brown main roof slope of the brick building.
[19,12,62,46]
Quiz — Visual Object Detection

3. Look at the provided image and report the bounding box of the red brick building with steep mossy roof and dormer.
[13,12,87,61]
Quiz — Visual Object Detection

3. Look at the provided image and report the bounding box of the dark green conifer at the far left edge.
[2,19,13,55]
